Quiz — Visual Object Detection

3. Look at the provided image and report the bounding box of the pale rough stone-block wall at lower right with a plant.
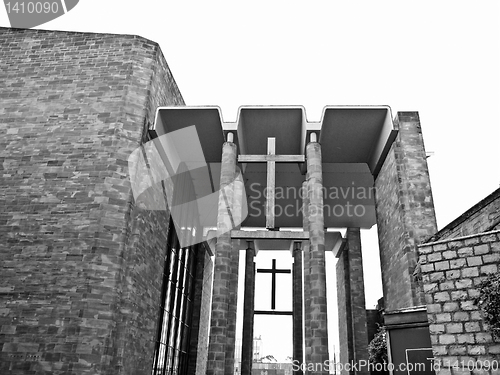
[419,231,500,375]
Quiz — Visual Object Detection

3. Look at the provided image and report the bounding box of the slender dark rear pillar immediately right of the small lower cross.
[292,242,304,375]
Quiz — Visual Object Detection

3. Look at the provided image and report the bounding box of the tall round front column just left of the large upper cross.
[207,142,236,375]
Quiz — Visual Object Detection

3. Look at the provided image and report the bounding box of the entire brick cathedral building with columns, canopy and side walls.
[0,28,500,375]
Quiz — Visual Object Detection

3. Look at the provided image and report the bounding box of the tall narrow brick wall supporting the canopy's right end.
[375,112,437,311]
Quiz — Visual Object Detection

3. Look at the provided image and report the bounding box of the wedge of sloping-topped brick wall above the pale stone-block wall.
[429,189,500,242]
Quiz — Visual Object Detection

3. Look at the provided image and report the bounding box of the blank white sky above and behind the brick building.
[0,0,500,364]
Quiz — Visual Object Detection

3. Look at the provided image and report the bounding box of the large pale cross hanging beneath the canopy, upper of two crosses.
[238,137,305,229]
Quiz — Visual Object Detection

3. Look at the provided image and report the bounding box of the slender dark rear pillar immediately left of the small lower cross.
[241,241,255,375]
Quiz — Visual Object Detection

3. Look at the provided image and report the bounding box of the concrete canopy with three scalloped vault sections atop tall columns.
[154,106,397,228]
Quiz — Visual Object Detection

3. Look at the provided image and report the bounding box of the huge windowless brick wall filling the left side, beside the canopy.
[0,28,183,375]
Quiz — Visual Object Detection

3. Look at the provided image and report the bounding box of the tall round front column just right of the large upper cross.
[306,142,329,375]
